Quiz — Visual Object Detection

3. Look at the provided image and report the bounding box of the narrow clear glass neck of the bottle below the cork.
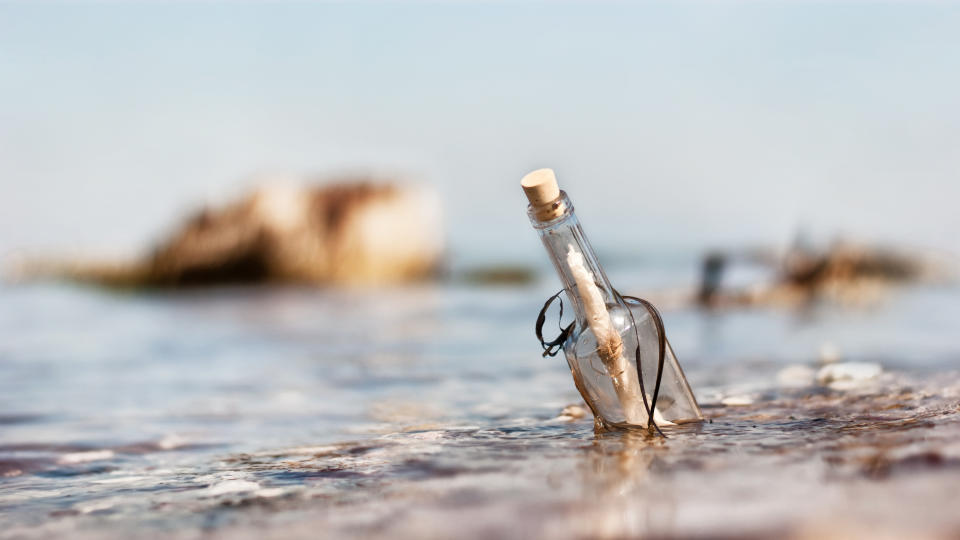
[527,191,619,328]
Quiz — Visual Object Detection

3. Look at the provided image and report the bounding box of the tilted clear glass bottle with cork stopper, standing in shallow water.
[521,169,703,430]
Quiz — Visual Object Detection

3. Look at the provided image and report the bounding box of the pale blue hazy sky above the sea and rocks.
[0,1,960,260]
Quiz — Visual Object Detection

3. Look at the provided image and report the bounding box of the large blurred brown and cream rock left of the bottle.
[22,181,444,287]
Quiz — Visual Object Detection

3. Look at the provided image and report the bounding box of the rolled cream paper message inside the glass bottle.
[567,244,672,425]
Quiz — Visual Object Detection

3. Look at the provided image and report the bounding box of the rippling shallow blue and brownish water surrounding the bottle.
[0,271,960,538]
